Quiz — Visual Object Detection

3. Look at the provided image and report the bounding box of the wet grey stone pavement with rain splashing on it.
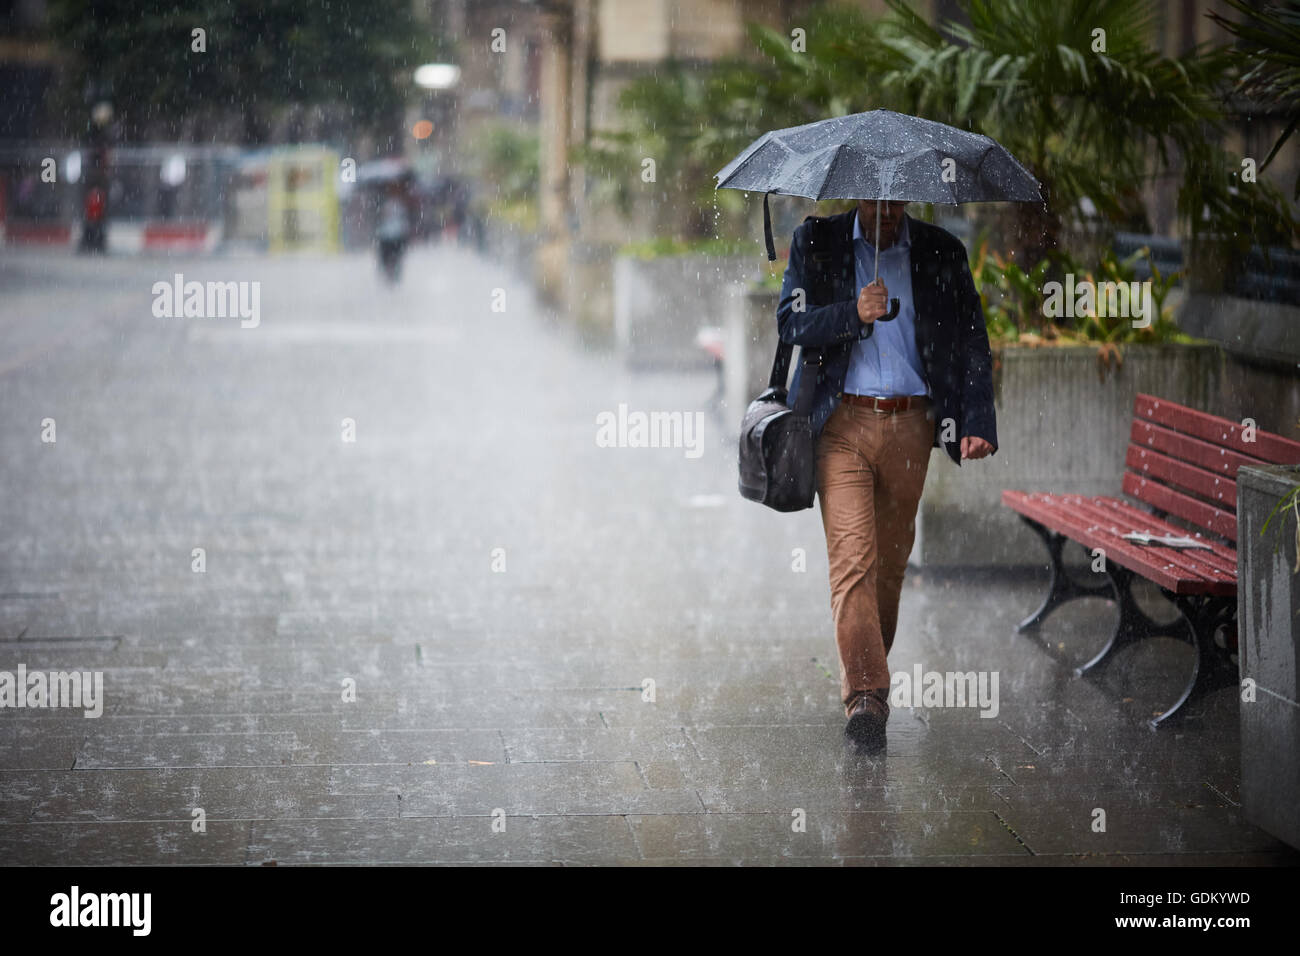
[0,248,1297,865]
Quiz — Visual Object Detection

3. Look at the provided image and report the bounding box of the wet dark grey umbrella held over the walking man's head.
[714,109,1043,319]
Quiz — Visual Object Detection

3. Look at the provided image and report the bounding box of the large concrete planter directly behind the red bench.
[913,345,1222,567]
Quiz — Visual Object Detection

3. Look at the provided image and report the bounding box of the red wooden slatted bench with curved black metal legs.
[1002,394,1300,730]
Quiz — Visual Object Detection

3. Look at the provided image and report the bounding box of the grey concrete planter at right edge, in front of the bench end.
[1236,466,1300,848]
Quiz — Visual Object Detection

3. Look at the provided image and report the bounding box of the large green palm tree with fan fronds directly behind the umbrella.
[880,0,1223,263]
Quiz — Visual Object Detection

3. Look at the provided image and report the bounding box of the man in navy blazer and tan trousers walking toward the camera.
[776,200,997,749]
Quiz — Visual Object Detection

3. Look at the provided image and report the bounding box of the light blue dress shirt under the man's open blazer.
[844,216,930,398]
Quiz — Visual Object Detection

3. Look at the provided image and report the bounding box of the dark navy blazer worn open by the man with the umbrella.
[776,209,997,464]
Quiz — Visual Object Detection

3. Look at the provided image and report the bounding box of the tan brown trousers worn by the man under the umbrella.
[816,401,935,713]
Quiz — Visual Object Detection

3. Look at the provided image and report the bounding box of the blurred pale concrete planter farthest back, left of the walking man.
[614,255,759,368]
